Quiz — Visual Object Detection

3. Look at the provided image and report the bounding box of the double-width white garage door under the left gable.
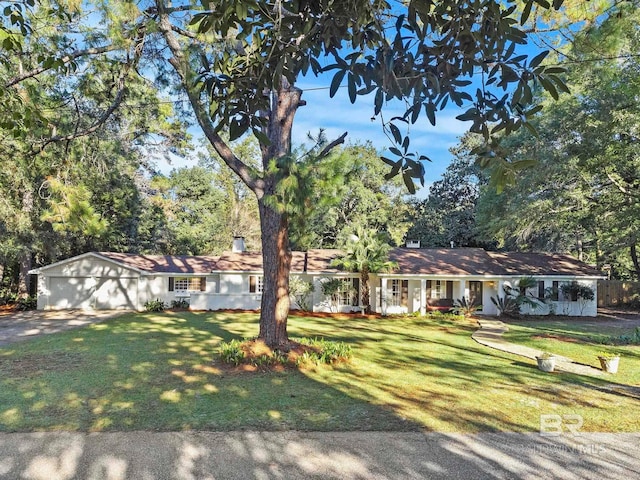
[49,277,138,310]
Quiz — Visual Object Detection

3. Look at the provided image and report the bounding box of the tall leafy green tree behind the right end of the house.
[472,8,640,278]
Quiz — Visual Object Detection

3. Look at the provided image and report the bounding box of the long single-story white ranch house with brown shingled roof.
[30,239,603,316]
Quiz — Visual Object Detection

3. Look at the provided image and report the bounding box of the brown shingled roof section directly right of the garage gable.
[98,252,218,273]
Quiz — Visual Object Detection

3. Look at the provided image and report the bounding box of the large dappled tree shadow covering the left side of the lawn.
[0,313,420,431]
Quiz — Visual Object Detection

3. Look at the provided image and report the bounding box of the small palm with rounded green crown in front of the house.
[332,227,397,312]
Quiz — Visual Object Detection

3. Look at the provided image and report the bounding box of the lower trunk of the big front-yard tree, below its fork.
[258,199,291,348]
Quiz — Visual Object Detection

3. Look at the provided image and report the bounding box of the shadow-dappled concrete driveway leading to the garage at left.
[0,310,126,346]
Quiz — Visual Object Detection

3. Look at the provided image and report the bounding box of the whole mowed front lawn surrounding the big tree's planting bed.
[0,312,640,432]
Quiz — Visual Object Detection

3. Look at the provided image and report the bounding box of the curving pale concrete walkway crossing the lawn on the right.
[471,318,603,376]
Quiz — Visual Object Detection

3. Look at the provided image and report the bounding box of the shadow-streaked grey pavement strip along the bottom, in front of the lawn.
[0,431,640,480]
